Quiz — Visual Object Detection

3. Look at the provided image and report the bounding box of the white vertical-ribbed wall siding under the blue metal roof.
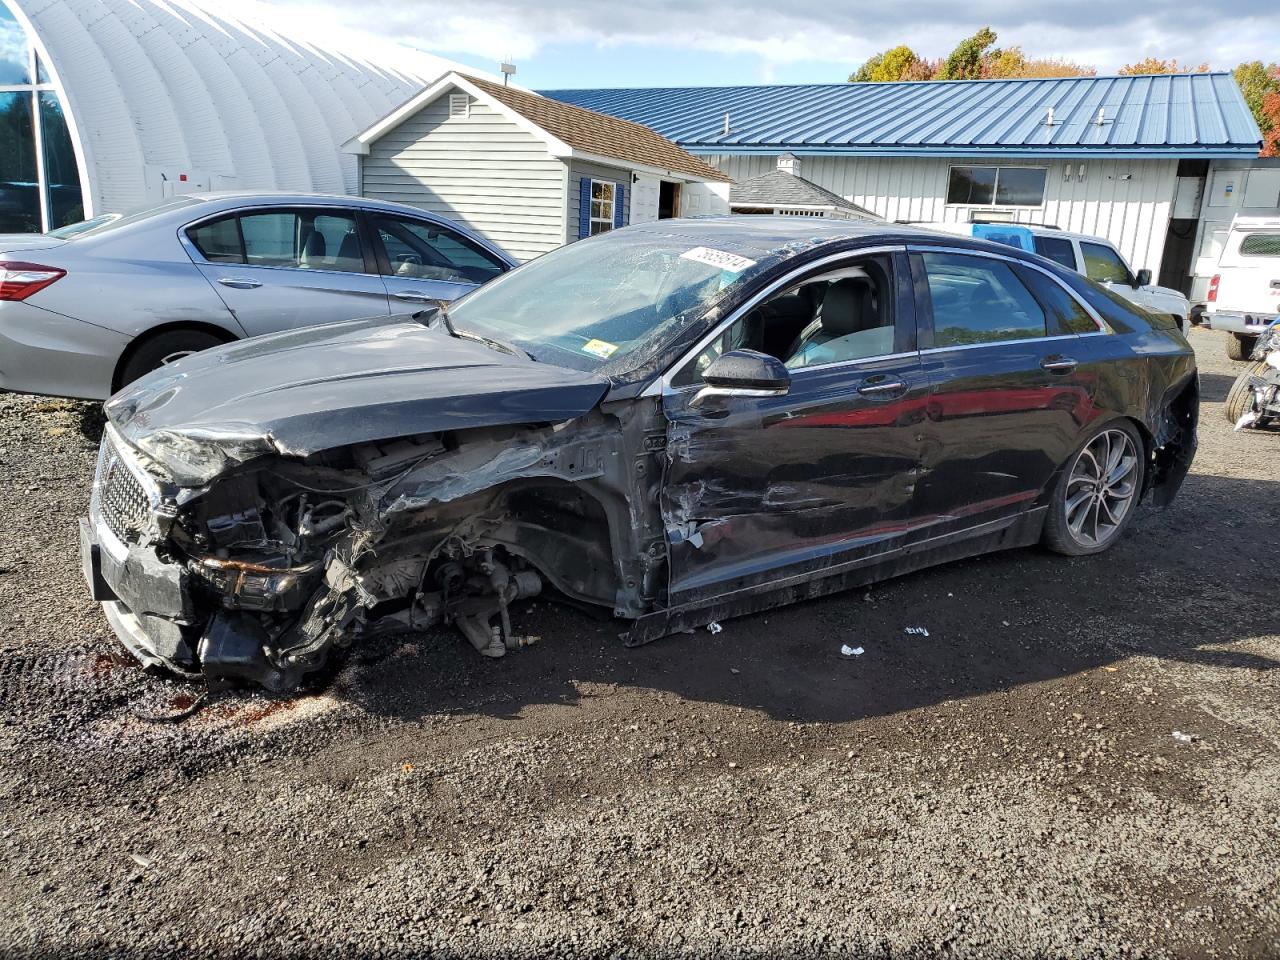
[703,155,1178,276]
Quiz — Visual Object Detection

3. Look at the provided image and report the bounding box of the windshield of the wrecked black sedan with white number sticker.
[449,228,778,374]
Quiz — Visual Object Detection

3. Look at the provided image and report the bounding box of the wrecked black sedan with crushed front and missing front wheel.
[81,216,1198,690]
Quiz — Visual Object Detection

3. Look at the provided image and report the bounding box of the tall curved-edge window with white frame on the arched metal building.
[0,0,84,233]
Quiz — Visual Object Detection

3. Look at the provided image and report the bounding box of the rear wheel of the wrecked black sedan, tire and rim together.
[1044,422,1146,557]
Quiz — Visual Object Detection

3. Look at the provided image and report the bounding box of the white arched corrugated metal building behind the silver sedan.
[0,0,471,232]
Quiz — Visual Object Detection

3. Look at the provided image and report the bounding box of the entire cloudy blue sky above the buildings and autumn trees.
[220,0,1280,88]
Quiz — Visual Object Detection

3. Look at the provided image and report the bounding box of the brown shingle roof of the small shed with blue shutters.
[458,74,731,182]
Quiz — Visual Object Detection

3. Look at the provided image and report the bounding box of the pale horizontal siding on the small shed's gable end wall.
[361,93,564,260]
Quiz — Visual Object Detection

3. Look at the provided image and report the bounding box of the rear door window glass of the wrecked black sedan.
[920,253,1046,347]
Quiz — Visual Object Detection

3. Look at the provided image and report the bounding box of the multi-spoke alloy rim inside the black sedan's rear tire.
[1066,430,1139,549]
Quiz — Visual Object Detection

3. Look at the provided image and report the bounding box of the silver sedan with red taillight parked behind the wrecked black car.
[0,193,516,399]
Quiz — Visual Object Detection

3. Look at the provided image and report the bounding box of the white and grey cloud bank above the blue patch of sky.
[223,0,1280,81]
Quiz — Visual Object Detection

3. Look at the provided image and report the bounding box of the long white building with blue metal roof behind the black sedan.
[544,73,1280,296]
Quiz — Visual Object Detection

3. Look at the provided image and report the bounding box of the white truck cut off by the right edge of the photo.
[1204,216,1280,360]
